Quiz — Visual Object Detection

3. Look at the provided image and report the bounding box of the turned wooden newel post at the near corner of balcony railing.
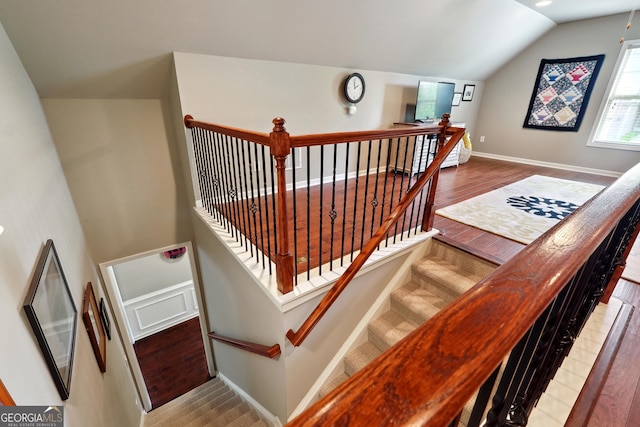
[269,117,293,294]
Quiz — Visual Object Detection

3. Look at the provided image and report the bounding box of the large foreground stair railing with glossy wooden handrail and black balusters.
[288,164,640,427]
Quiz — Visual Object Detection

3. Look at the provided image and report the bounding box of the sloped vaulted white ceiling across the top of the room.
[0,0,640,98]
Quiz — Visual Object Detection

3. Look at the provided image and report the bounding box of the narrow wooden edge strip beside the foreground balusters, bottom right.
[565,303,635,427]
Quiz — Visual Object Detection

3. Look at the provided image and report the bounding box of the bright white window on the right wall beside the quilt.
[587,40,640,151]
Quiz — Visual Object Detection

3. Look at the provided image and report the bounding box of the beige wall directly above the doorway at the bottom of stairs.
[42,99,191,263]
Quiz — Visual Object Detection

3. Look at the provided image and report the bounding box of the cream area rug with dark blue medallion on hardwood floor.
[436,175,604,244]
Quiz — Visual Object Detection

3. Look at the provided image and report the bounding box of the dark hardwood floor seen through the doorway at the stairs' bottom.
[133,317,211,409]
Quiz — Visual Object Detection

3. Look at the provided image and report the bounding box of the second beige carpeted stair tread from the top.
[391,282,447,325]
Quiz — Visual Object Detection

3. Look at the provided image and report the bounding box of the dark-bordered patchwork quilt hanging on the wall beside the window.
[524,55,604,132]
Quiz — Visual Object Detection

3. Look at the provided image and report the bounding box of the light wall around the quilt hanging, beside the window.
[472,14,640,172]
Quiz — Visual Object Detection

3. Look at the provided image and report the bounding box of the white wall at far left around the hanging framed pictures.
[0,25,140,427]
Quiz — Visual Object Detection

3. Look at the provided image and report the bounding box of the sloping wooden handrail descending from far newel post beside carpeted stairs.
[287,118,464,347]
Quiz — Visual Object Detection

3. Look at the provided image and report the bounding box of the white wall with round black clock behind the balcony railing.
[174,53,482,135]
